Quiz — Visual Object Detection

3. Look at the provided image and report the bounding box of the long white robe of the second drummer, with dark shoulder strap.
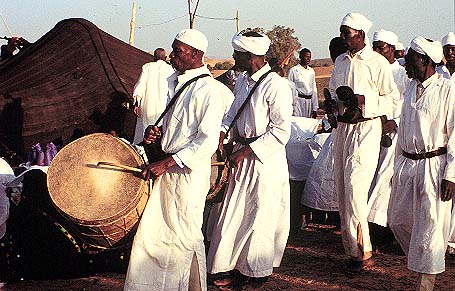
[207,64,292,277]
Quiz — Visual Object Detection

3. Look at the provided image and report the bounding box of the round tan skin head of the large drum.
[47,133,147,224]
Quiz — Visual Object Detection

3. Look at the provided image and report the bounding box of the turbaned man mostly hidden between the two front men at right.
[368,29,410,229]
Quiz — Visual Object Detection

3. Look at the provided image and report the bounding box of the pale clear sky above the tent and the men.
[0,0,455,59]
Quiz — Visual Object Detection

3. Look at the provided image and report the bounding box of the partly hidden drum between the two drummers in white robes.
[206,150,229,203]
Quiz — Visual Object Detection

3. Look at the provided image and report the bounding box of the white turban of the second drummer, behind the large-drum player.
[232,32,271,56]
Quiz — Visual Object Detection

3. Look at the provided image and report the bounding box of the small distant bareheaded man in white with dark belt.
[287,48,319,118]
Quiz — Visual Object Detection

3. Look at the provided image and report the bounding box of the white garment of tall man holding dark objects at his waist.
[329,47,399,257]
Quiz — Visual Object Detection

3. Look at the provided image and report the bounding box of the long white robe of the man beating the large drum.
[125,66,232,291]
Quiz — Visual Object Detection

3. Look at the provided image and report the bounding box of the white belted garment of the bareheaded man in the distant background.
[287,64,319,117]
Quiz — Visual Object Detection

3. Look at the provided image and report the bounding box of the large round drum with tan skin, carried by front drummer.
[47,133,149,253]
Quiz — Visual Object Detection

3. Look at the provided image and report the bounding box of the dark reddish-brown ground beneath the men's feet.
[0,224,455,291]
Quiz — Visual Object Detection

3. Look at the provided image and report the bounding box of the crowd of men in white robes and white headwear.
[125,13,455,291]
